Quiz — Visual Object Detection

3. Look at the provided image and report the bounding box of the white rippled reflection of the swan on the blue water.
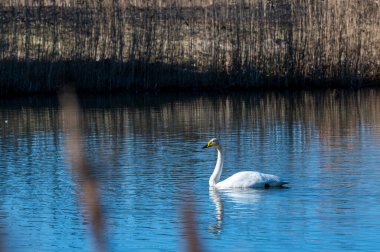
[209,187,264,235]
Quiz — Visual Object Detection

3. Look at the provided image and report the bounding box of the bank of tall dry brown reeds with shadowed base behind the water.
[0,0,380,94]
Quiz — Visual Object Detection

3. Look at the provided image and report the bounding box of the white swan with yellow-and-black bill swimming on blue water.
[203,138,288,189]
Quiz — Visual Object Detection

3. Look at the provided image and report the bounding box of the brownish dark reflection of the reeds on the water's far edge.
[0,90,380,143]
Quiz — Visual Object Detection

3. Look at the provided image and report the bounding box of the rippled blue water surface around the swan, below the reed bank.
[0,90,380,251]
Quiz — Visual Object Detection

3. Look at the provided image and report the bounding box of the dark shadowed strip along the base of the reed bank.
[0,57,380,97]
